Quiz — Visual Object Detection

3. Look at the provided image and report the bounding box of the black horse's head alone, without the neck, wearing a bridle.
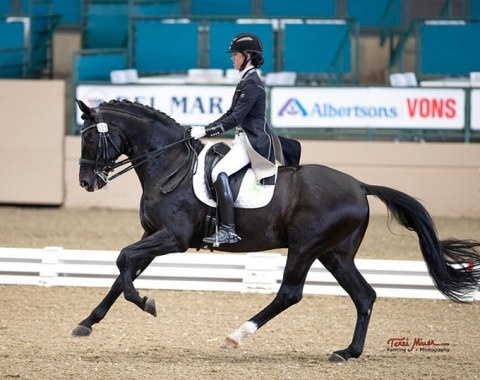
[77,100,124,191]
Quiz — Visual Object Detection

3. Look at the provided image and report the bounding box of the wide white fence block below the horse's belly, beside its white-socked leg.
[242,252,282,293]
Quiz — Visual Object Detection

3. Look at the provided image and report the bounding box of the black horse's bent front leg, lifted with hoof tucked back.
[117,230,180,317]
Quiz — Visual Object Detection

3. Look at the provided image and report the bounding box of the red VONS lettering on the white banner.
[407,98,457,119]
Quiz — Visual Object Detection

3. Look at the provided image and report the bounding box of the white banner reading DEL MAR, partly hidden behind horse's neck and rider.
[76,85,235,125]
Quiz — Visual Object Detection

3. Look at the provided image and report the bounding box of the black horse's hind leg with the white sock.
[222,251,315,348]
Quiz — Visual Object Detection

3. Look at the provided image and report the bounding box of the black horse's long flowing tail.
[362,184,480,302]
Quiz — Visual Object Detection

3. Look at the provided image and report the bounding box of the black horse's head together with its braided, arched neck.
[77,100,196,192]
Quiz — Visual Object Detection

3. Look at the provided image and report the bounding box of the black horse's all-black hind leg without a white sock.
[319,251,376,362]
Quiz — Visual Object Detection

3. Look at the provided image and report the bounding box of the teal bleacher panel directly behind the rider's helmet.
[208,21,275,72]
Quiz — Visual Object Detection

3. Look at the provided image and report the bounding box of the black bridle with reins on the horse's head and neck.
[79,112,197,194]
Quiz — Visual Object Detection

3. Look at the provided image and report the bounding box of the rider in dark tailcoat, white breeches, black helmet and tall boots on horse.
[189,33,283,244]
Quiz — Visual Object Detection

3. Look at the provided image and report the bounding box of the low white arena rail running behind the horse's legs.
[0,247,480,300]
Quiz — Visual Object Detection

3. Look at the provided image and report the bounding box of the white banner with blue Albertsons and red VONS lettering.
[270,87,465,129]
